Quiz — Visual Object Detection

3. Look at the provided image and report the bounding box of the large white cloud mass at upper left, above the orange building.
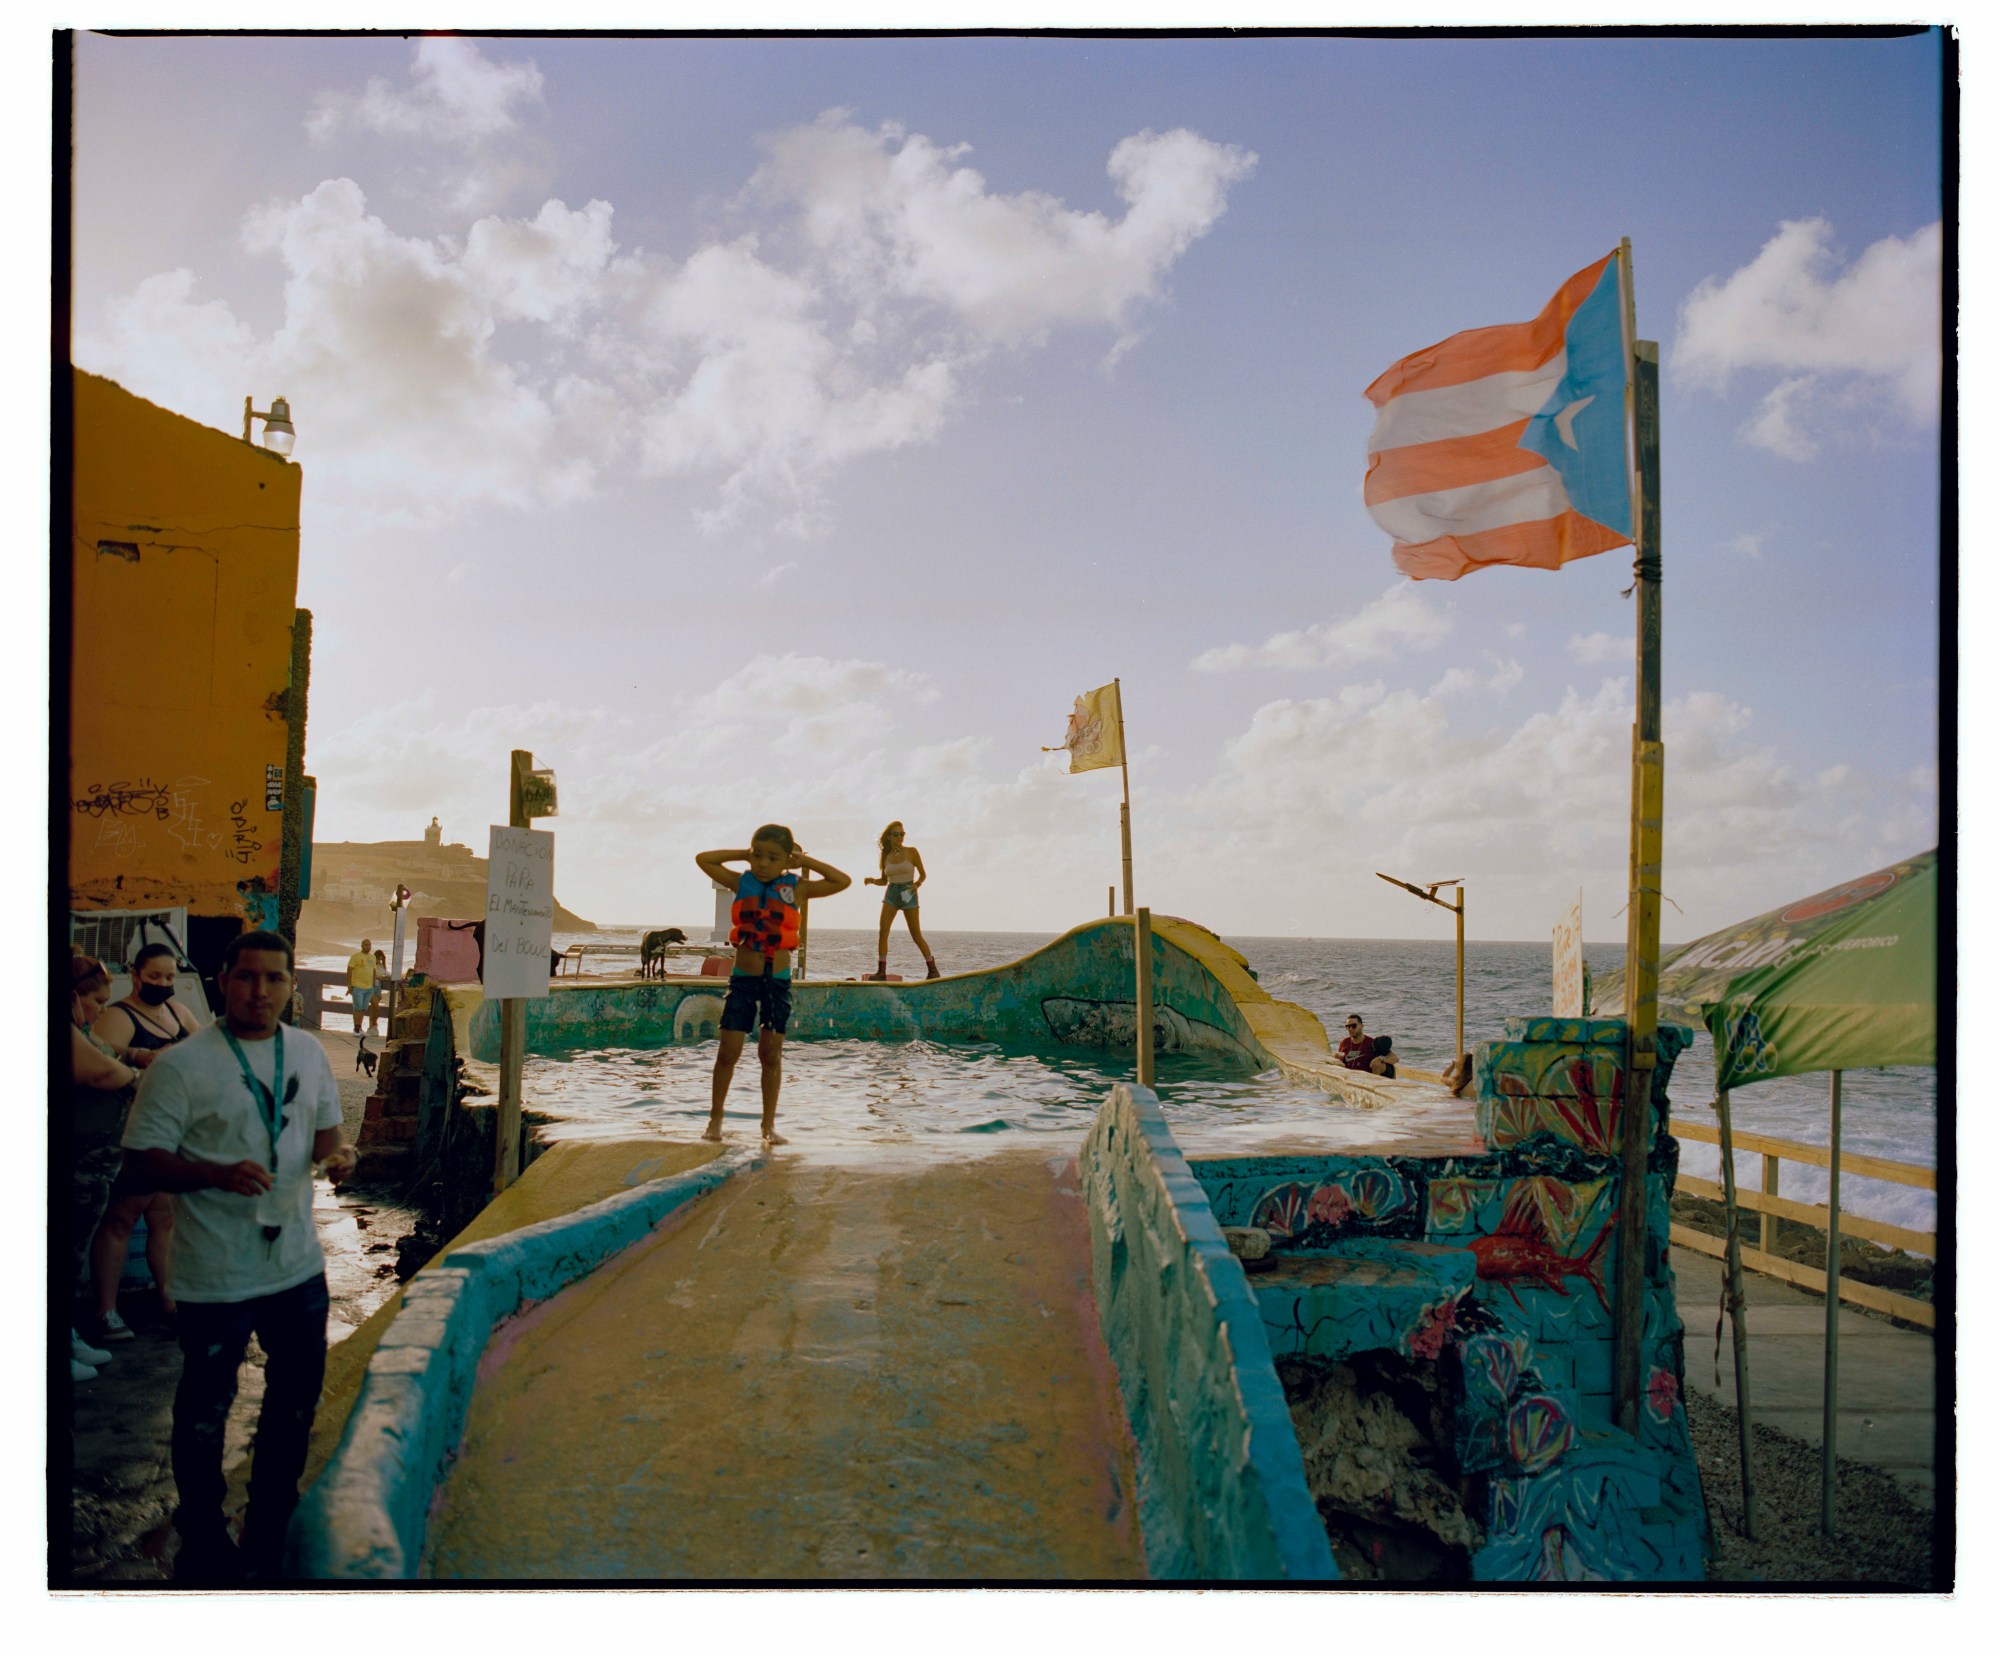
[90,81,1254,534]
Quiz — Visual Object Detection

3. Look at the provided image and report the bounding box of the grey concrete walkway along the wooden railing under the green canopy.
[1674,1248,1938,1506]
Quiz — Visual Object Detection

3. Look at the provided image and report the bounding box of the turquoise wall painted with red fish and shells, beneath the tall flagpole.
[1192,1018,1708,1582]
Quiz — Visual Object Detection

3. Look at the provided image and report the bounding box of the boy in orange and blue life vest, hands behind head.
[694,822,854,1144]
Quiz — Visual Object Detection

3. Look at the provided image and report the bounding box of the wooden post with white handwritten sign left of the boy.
[494,748,556,1196]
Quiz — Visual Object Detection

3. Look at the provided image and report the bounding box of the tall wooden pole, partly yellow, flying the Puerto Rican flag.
[1612,238,1666,1434]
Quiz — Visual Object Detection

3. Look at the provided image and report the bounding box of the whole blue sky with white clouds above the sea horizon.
[74,34,1942,940]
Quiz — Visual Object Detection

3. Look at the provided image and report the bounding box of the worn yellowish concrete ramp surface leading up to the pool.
[426,1150,1144,1580]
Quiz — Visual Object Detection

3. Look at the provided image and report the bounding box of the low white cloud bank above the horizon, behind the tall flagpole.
[1150,678,1936,938]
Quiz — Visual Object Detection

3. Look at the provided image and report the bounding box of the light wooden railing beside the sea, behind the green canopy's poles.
[1668,1116,1938,1330]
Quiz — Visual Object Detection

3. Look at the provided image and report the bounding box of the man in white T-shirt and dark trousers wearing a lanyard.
[124,932,354,1582]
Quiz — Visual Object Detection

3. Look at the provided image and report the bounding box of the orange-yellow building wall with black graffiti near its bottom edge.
[68,372,300,924]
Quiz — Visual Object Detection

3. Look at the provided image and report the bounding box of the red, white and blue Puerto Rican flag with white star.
[1362,254,1632,580]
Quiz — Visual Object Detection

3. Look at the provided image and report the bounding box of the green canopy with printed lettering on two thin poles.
[1592,850,1938,1538]
